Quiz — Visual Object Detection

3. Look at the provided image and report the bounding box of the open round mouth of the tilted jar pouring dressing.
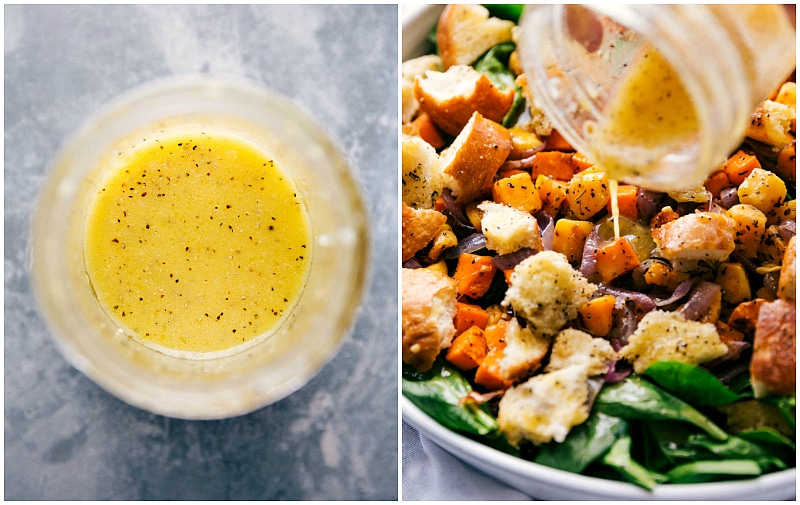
[519,4,749,190]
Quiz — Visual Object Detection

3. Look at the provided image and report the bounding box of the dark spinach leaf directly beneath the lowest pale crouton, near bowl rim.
[534,413,628,473]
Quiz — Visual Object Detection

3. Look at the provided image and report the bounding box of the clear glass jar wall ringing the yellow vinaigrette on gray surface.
[32,77,369,419]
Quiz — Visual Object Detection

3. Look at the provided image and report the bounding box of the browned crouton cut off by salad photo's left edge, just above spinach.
[402,268,457,372]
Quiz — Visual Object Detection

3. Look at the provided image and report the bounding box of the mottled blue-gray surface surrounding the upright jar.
[4,5,398,500]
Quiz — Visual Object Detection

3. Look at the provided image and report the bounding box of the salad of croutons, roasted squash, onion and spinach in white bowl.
[401,5,796,498]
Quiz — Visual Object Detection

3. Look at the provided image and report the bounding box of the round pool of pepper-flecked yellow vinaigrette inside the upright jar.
[84,130,311,353]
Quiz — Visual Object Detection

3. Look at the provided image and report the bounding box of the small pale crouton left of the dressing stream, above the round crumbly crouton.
[478,201,542,254]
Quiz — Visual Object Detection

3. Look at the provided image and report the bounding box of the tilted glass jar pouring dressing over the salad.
[519,4,796,191]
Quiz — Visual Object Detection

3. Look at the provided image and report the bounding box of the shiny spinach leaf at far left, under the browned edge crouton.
[402,361,497,435]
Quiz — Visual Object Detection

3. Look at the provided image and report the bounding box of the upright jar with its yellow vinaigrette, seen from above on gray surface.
[32,76,369,419]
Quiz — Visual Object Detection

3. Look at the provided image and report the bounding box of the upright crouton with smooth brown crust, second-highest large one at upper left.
[439,112,511,202]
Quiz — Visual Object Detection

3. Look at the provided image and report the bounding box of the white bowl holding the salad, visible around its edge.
[401,5,797,500]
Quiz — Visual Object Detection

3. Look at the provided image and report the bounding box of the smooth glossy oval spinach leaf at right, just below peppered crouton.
[645,361,741,407]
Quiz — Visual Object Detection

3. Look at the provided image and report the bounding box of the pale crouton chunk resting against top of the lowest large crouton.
[545,328,617,377]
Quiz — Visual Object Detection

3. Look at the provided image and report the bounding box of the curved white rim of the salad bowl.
[400,4,797,500]
